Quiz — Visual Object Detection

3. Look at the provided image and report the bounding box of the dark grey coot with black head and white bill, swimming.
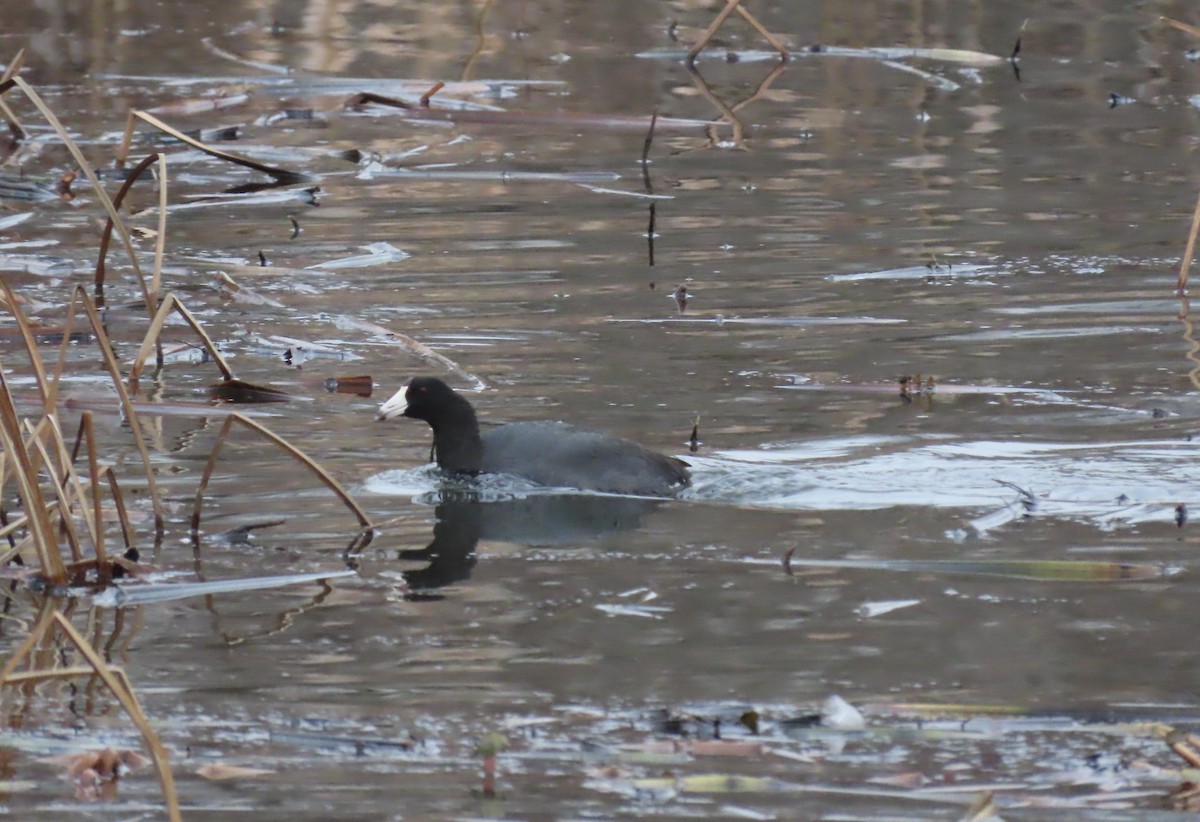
[379,377,691,497]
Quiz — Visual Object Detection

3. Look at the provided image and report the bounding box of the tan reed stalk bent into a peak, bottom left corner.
[0,607,184,822]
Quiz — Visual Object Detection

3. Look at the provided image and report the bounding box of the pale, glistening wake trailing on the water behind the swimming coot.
[684,437,1200,521]
